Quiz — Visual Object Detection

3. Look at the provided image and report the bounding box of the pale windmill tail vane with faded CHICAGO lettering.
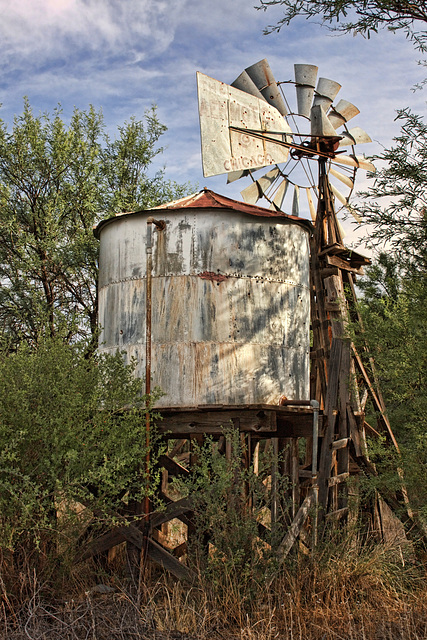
[197,72,291,177]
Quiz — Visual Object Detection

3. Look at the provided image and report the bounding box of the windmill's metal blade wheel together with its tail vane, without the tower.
[197,59,375,235]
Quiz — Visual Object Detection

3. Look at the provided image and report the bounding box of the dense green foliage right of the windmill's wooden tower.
[359,253,427,521]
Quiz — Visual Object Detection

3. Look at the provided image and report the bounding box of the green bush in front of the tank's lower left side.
[0,338,163,569]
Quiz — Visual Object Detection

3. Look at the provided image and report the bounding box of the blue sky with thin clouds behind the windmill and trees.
[0,0,427,250]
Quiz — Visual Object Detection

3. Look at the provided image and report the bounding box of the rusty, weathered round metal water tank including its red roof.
[95,189,310,407]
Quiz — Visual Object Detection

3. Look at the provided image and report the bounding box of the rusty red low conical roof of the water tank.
[94,187,313,238]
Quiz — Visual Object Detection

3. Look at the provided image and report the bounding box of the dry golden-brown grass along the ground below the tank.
[0,545,427,640]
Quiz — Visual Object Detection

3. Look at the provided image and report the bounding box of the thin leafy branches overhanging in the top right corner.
[257,0,427,51]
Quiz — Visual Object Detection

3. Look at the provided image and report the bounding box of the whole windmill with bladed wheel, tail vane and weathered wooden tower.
[197,59,422,540]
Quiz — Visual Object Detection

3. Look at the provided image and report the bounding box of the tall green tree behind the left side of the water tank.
[0,101,189,344]
